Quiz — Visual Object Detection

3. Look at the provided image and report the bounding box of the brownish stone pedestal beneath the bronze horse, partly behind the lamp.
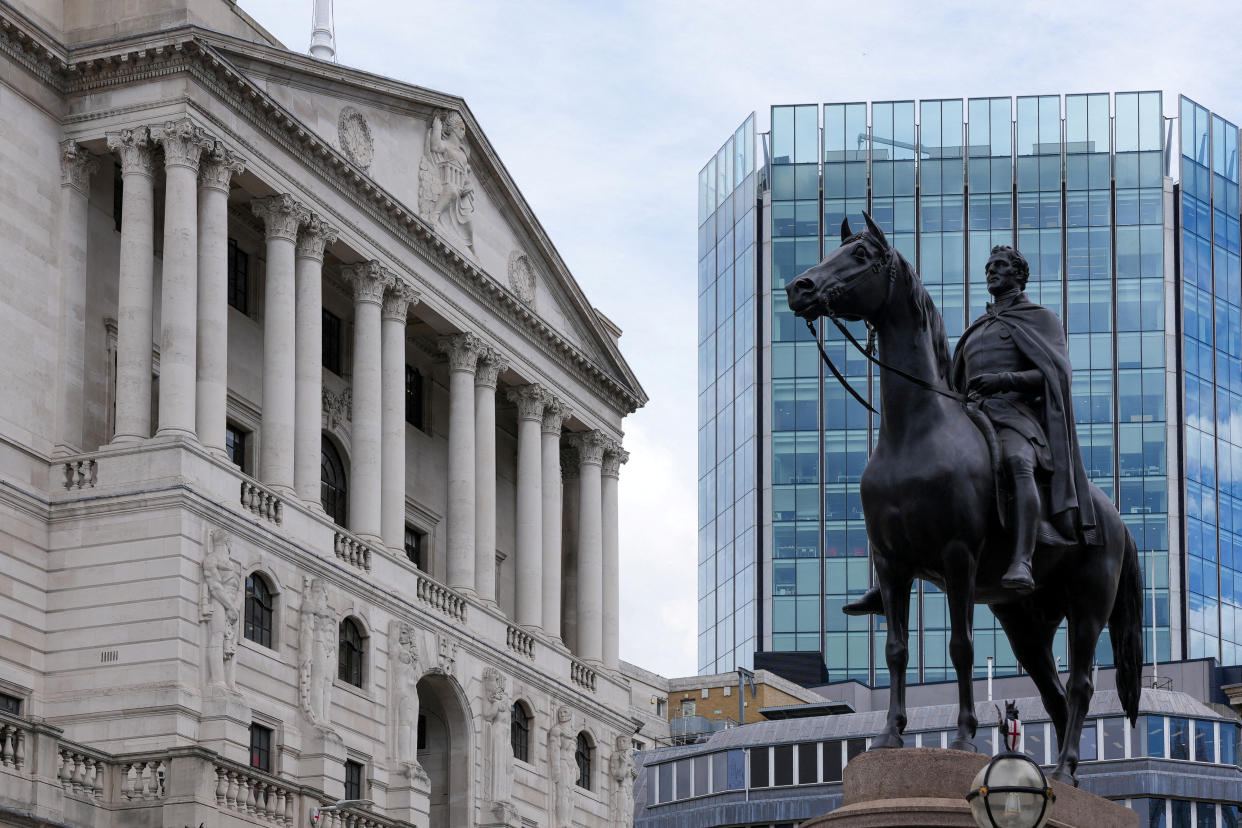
[801,747,1139,828]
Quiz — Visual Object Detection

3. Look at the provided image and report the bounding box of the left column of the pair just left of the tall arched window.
[251,194,309,493]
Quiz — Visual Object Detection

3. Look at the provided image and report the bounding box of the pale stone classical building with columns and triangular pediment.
[0,0,646,828]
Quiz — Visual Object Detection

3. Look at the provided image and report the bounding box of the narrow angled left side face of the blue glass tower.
[698,115,759,673]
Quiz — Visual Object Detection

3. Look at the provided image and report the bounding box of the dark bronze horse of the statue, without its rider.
[785,215,1143,785]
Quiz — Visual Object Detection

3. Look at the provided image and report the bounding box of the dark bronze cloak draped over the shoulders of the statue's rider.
[949,293,1099,545]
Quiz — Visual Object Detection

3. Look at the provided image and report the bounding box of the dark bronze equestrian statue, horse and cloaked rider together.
[785,214,1143,783]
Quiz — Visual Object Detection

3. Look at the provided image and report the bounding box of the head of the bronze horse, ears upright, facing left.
[785,212,897,322]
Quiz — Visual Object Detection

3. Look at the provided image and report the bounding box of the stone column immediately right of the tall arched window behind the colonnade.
[342,262,392,542]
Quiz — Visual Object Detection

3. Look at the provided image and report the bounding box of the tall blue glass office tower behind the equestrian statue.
[698,92,1242,684]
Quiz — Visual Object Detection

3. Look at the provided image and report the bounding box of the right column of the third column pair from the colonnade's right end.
[474,348,509,603]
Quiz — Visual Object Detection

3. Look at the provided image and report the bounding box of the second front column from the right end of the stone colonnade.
[574,431,607,664]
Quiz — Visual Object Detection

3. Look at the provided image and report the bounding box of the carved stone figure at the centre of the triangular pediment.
[419,112,474,253]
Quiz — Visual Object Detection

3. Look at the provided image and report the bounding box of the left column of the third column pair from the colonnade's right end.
[440,334,483,593]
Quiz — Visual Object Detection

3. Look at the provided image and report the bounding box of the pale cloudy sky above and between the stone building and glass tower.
[240,0,1242,675]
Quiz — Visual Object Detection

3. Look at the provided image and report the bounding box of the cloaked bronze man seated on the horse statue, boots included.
[845,245,1098,614]
